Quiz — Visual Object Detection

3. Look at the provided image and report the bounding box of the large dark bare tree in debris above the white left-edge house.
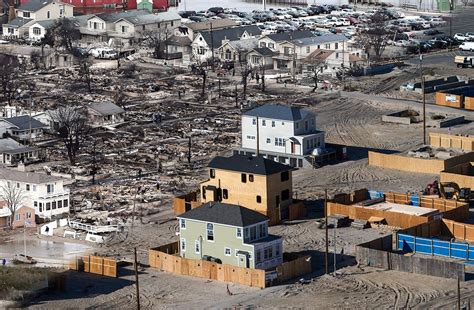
[50,106,90,165]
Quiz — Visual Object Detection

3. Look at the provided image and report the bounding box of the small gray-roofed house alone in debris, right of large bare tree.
[87,102,125,126]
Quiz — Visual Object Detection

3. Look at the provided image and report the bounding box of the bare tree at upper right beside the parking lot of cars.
[360,11,390,60]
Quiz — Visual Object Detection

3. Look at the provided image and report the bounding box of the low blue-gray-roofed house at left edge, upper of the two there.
[0,115,48,141]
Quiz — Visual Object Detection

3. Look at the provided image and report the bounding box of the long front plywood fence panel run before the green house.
[148,249,265,288]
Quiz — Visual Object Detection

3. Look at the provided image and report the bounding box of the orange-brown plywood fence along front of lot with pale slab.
[328,202,433,228]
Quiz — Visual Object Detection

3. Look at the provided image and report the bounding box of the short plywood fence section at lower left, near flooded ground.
[69,255,117,277]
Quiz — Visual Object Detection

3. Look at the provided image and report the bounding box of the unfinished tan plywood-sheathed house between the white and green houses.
[201,155,293,225]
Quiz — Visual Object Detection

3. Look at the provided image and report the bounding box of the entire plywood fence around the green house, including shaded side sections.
[148,242,311,288]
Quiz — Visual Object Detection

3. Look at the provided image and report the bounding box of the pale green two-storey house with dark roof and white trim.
[178,202,283,269]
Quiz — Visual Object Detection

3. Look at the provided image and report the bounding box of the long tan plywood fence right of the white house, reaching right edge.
[369,151,474,174]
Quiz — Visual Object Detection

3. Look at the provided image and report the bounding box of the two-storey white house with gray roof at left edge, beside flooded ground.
[0,168,70,218]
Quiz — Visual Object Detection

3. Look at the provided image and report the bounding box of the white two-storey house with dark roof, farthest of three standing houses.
[239,104,325,167]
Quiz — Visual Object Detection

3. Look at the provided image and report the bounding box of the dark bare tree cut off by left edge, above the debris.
[0,54,21,105]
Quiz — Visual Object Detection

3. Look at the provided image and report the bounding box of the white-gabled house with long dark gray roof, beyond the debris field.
[191,25,262,61]
